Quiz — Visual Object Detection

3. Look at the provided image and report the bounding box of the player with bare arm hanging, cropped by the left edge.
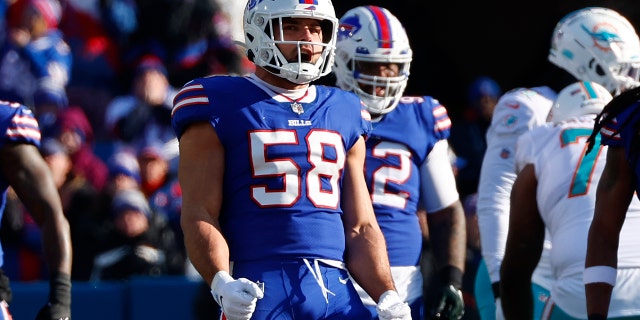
[0,101,71,320]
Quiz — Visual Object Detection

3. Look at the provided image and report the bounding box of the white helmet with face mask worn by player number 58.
[244,0,338,84]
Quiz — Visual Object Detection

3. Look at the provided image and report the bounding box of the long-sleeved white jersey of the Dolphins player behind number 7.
[477,87,556,289]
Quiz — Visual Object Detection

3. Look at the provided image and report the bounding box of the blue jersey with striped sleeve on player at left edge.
[0,101,40,266]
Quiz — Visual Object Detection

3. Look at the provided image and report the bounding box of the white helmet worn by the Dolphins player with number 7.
[547,81,612,123]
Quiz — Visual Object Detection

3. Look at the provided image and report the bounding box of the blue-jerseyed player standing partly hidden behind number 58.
[334,6,466,319]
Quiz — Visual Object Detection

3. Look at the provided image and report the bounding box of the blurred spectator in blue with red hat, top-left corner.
[0,0,73,109]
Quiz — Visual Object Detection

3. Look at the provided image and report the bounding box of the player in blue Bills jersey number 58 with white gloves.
[172,0,410,320]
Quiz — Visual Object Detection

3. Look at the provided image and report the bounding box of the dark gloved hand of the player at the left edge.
[36,273,71,320]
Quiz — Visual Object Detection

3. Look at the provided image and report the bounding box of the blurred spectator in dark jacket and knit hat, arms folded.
[90,189,185,281]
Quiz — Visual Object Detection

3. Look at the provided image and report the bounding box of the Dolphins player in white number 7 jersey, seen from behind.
[500,82,640,319]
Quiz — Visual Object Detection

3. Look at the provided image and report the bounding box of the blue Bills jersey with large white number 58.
[172,76,371,261]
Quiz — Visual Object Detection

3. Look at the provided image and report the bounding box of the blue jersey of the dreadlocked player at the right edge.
[600,102,640,198]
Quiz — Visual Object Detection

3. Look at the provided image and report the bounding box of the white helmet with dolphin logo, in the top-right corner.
[549,7,640,95]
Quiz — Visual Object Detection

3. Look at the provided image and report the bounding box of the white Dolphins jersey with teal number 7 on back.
[515,115,640,318]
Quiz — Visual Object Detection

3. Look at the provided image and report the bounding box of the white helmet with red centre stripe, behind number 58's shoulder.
[333,6,413,115]
